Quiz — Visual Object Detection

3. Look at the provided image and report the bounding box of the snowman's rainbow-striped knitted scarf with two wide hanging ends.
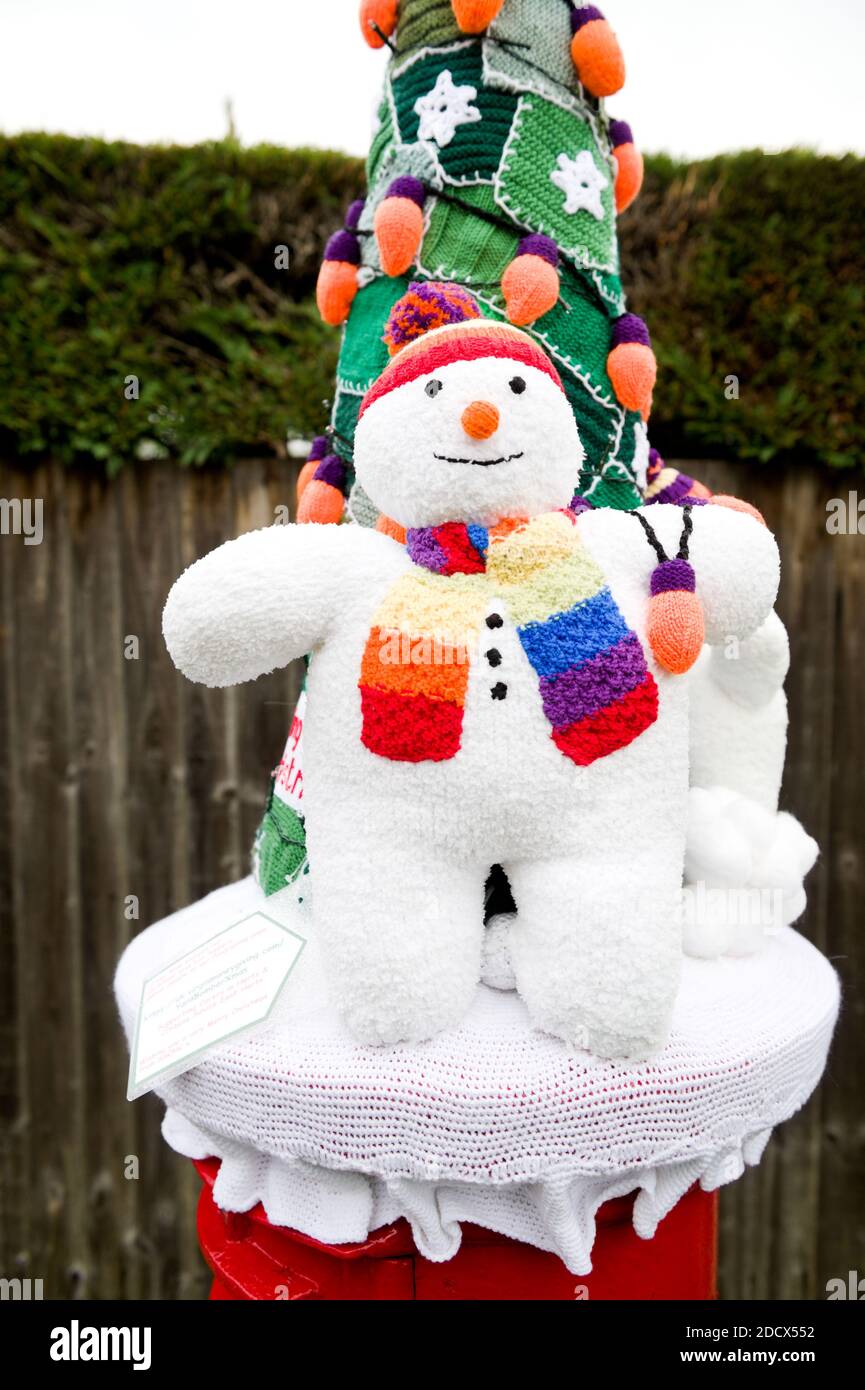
[359,512,658,767]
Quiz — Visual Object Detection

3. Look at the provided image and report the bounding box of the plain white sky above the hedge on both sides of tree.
[0,0,865,157]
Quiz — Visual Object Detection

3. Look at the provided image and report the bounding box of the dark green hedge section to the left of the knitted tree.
[0,135,363,471]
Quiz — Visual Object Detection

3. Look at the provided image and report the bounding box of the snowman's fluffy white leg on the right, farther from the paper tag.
[505,842,681,1061]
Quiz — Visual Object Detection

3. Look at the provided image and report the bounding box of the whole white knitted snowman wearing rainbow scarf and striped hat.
[164,292,777,1059]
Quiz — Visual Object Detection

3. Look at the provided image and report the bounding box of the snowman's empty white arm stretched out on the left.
[163,525,399,685]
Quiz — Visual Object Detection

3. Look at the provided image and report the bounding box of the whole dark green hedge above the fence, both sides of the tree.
[0,135,865,471]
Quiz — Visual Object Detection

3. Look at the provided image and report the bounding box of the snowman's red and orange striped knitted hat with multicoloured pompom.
[359,281,565,418]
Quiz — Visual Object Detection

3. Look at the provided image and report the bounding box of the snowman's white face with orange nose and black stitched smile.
[355,357,583,527]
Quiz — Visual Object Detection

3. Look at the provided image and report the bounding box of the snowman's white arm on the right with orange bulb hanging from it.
[580,503,780,646]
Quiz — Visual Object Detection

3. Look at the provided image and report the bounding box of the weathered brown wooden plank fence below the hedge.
[0,460,865,1298]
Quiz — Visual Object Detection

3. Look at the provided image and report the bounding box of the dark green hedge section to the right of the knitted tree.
[620,150,865,467]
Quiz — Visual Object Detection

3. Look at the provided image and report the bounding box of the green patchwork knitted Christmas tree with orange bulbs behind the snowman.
[254,0,706,891]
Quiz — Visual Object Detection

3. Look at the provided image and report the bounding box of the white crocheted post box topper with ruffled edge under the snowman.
[115,878,839,1275]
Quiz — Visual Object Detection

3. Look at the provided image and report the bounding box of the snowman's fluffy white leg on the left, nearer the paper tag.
[310,827,485,1043]
